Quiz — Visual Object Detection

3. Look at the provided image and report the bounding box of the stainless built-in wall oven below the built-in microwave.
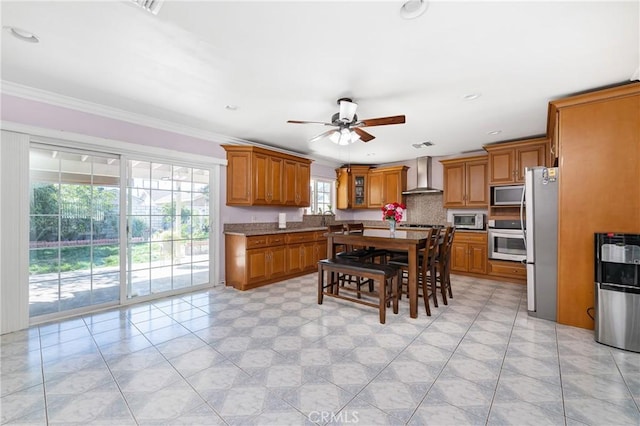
[488,220,527,262]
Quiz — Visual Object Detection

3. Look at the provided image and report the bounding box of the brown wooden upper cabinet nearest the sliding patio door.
[222,145,311,207]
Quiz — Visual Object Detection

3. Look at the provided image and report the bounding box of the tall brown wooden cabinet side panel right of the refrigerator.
[549,82,640,328]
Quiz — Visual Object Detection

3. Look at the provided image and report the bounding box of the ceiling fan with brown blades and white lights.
[287,98,405,145]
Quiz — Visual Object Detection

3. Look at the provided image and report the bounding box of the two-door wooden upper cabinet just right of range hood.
[440,155,489,208]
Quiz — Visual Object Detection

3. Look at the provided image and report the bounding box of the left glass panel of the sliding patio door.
[29,147,120,317]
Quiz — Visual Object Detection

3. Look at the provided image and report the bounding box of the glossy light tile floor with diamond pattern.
[0,274,640,426]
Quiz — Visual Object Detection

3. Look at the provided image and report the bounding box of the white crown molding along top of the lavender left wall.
[0,80,251,144]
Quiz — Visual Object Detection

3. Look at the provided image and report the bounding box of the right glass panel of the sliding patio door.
[127,160,210,298]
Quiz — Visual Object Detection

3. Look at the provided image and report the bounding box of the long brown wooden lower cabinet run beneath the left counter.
[225,231,327,290]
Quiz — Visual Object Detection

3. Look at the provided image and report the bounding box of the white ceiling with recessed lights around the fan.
[1,0,640,163]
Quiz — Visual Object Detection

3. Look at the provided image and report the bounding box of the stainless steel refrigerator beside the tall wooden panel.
[520,167,559,321]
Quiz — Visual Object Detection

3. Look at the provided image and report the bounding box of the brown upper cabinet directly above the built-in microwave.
[484,138,549,185]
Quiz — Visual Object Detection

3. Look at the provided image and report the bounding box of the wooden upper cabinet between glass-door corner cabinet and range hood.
[368,166,409,208]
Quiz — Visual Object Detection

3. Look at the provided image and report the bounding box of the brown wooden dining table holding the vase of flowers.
[325,228,427,318]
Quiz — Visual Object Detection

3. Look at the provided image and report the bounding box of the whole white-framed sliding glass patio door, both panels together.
[29,145,211,320]
